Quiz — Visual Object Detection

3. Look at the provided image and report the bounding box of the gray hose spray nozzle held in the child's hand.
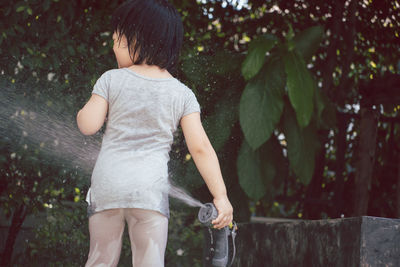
[198,203,237,267]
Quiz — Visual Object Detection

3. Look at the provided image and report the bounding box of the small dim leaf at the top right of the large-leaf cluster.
[293,26,324,61]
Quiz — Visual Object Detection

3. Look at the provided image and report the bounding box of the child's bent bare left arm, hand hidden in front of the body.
[76,94,108,135]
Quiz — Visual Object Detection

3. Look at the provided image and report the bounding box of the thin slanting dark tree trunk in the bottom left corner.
[0,203,27,267]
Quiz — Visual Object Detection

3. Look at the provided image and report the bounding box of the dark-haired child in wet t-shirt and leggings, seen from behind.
[77,0,233,266]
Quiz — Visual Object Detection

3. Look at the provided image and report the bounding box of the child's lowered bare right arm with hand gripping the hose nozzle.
[181,112,233,228]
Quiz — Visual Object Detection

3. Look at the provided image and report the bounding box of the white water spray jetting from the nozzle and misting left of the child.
[0,88,203,207]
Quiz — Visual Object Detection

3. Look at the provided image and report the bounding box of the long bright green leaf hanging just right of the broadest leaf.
[283,51,315,128]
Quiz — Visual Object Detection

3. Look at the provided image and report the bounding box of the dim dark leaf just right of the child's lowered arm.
[204,100,237,151]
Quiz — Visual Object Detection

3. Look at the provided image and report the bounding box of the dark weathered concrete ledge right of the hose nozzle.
[233,216,400,267]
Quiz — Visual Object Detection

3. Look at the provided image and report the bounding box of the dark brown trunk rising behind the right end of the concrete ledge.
[353,107,379,216]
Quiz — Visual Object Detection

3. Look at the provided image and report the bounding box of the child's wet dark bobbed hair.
[112,0,183,70]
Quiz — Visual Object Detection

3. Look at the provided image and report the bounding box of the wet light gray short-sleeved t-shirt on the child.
[86,68,200,217]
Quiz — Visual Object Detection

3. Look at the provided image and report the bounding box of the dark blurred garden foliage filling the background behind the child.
[0,0,400,266]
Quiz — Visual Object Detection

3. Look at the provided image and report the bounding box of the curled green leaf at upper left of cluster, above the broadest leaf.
[242,34,278,80]
